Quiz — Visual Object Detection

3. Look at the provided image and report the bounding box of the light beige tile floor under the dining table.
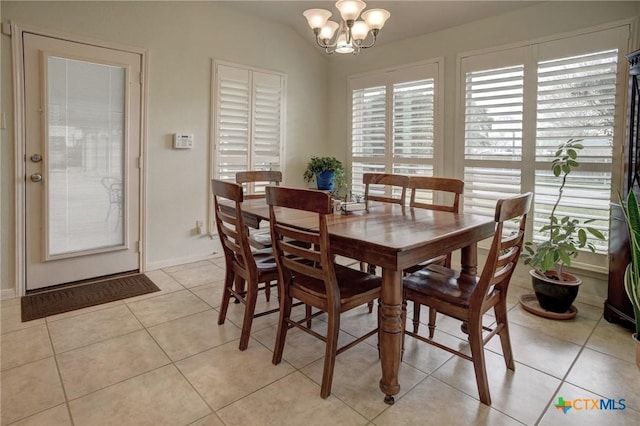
[0,258,640,426]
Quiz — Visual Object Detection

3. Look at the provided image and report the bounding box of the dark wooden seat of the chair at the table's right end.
[403,265,478,308]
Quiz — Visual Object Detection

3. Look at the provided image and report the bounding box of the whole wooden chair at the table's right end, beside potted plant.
[403,192,532,405]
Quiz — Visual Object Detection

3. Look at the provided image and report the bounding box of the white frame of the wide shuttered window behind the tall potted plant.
[454,20,634,273]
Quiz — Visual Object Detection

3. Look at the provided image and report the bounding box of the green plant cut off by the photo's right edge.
[621,191,640,369]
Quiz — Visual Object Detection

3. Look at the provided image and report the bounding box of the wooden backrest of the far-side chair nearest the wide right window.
[409,176,464,213]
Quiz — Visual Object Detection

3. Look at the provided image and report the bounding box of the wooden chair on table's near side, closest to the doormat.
[211,179,279,351]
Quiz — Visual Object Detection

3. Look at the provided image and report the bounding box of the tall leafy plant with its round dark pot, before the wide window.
[522,139,604,313]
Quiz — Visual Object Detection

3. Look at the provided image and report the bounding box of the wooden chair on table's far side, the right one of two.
[404,175,464,337]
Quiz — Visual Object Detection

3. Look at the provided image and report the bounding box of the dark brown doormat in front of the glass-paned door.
[20,274,160,322]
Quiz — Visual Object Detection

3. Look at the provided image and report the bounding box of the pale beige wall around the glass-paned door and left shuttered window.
[0,0,328,289]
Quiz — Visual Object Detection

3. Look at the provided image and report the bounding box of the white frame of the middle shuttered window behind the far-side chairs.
[347,57,445,199]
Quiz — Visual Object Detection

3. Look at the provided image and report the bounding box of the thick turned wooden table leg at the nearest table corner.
[379,268,402,404]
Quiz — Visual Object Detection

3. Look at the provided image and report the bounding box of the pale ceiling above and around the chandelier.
[223,0,540,44]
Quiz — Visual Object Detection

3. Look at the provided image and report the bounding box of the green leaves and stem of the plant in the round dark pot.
[522,139,604,281]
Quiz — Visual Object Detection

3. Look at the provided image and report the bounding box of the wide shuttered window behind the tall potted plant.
[461,26,629,267]
